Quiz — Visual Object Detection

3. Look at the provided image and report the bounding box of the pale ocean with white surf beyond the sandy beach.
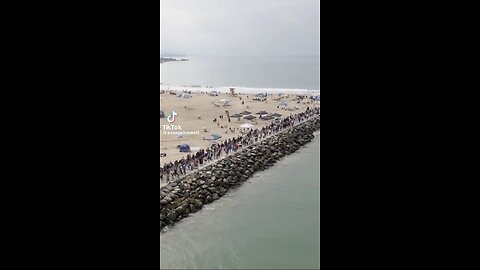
[160,56,320,90]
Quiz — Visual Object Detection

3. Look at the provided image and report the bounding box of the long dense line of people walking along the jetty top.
[160,108,320,183]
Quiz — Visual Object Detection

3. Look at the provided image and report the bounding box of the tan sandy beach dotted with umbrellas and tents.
[160,86,320,165]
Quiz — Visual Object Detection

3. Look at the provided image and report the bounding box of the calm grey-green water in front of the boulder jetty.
[160,135,320,269]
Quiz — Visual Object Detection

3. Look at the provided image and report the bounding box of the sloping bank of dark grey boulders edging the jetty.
[160,117,320,231]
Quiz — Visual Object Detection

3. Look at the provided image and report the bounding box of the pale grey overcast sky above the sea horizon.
[160,0,320,55]
